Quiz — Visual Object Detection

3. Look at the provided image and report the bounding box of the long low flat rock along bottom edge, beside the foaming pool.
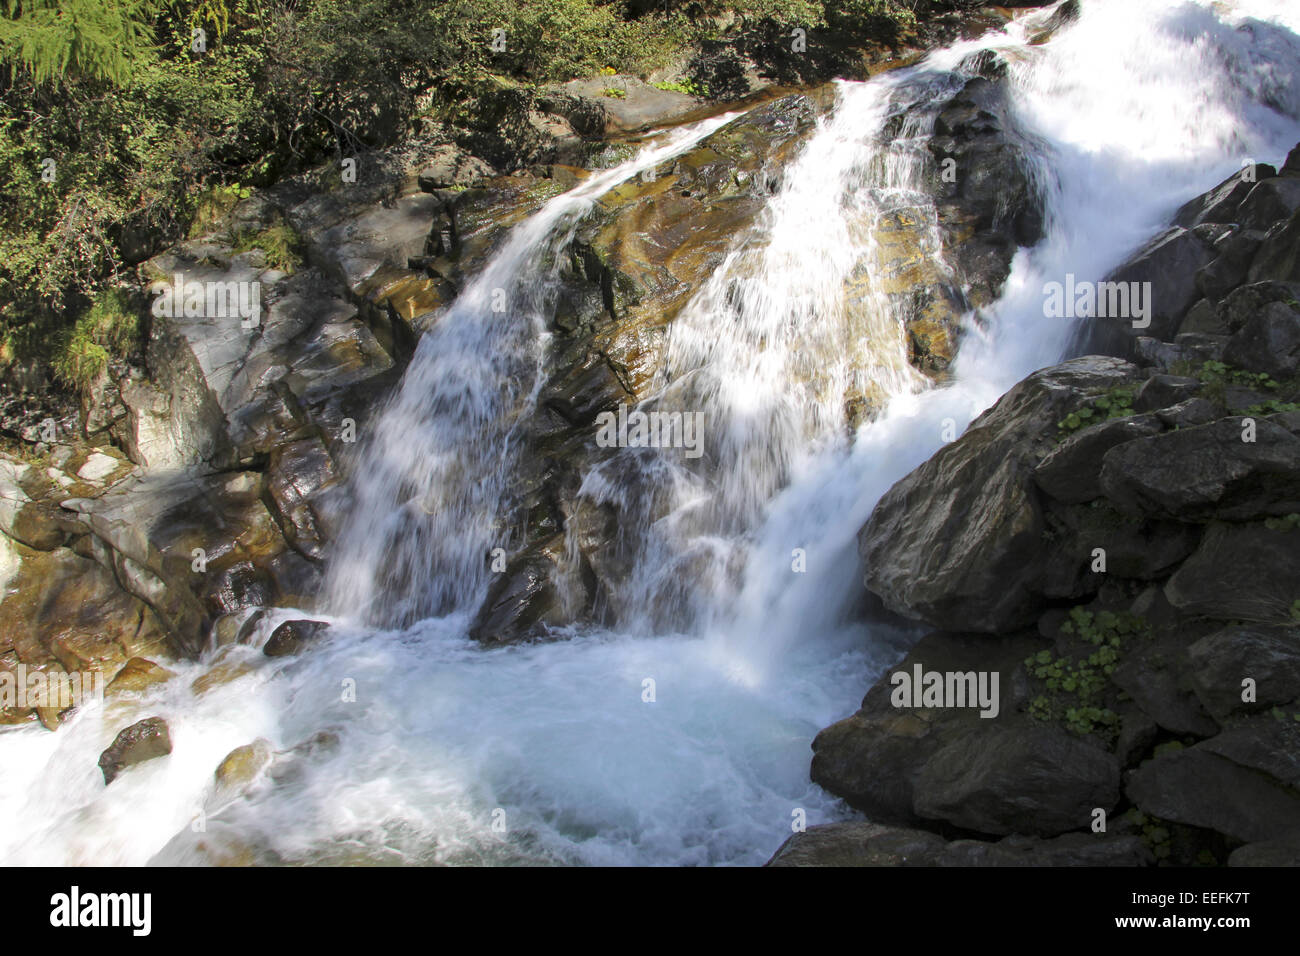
[766,822,1152,866]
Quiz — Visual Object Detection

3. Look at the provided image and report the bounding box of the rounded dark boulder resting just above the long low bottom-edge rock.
[914,724,1119,836]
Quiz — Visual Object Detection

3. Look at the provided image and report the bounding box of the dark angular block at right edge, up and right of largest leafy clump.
[1165,522,1300,623]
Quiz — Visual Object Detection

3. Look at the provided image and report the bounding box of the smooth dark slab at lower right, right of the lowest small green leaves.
[1126,745,1300,843]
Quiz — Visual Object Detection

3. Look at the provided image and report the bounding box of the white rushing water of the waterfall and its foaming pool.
[0,0,1300,864]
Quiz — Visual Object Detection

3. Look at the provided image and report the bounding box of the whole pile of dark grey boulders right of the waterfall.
[806,145,1300,865]
